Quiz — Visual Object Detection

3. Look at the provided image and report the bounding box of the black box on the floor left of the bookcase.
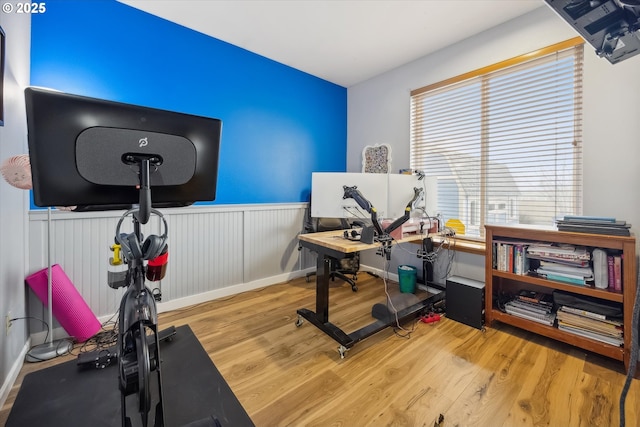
[445,276,484,329]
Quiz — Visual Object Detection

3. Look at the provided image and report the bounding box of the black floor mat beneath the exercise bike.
[6,326,254,427]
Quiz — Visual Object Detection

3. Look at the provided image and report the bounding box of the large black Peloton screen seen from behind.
[25,87,222,210]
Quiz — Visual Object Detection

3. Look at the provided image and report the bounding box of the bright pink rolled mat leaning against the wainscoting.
[25,264,101,342]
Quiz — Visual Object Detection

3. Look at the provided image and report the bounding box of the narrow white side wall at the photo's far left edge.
[0,13,31,406]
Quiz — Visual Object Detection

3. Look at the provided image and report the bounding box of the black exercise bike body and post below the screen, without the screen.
[110,156,170,427]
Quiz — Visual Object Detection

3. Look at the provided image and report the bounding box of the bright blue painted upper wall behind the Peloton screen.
[31,0,347,204]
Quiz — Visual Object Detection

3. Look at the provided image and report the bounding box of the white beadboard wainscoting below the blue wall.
[28,203,315,324]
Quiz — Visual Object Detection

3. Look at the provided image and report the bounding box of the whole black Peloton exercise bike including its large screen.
[25,88,222,427]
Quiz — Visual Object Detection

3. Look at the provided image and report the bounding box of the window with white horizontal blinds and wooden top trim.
[411,38,583,237]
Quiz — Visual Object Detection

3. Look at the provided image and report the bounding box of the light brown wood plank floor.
[0,273,640,427]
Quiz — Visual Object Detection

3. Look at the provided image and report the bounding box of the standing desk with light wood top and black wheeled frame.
[296,230,444,359]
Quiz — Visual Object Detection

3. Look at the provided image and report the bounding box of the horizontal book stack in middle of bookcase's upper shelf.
[527,244,594,286]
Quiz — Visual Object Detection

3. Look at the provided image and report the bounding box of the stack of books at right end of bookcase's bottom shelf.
[557,306,624,346]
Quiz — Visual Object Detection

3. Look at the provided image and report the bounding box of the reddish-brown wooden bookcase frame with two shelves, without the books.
[485,225,637,376]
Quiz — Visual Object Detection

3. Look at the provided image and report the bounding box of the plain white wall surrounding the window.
[347,5,640,282]
